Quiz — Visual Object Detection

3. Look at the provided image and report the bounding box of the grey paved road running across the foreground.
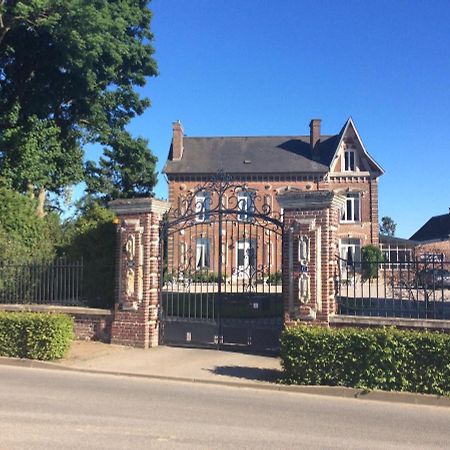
[0,366,450,450]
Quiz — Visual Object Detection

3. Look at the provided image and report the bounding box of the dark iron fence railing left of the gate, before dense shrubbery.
[0,258,86,306]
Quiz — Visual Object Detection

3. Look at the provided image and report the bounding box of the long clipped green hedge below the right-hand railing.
[281,326,450,395]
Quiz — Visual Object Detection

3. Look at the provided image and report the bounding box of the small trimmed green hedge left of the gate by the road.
[0,312,74,360]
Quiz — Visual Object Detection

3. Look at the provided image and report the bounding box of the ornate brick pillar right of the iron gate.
[278,191,345,325]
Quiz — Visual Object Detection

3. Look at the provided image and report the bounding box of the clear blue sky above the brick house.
[92,0,450,237]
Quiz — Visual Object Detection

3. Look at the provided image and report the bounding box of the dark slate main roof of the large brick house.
[164,136,338,174]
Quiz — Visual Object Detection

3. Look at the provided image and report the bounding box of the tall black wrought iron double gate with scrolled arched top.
[160,172,283,350]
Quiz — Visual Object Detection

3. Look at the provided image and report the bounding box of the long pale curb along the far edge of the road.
[0,357,450,408]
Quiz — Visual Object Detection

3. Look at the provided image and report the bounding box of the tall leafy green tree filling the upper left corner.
[0,0,157,209]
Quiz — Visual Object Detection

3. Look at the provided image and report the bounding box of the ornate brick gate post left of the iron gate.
[109,198,170,348]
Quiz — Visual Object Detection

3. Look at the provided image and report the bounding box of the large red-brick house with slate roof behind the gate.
[164,118,383,278]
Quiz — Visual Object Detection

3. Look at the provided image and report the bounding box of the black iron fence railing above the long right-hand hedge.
[336,259,450,320]
